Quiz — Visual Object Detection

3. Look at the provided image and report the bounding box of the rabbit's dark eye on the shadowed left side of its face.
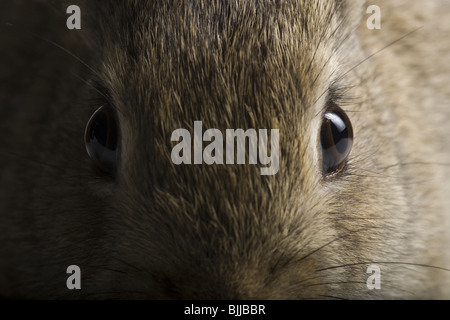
[85,105,118,175]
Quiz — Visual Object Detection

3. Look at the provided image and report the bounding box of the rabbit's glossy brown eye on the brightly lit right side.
[320,105,353,176]
